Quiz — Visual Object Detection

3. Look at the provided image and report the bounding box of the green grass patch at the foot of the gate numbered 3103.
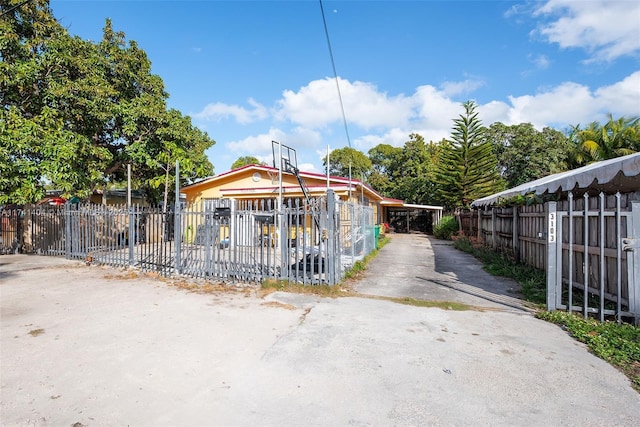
[536,311,640,392]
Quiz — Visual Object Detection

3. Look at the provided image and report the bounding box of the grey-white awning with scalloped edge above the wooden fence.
[471,153,640,208]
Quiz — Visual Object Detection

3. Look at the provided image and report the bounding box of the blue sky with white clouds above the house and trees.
[51,0,640,173]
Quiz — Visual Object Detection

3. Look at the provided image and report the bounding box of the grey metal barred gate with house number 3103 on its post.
[547,193,640,323]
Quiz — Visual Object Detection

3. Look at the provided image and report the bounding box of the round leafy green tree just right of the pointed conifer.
[486,122,569,188]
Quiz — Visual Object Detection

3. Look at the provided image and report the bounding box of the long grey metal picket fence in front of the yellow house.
[0,191,375,284]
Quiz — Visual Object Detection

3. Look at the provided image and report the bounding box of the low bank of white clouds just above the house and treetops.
[205,71,640,171]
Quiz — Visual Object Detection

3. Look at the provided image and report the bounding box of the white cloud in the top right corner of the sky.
[533,0,640,61]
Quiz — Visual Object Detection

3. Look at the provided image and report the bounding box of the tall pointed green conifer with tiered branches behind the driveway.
[435,101,504,209]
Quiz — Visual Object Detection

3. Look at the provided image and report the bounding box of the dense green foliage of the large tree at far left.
[0,0,214,203]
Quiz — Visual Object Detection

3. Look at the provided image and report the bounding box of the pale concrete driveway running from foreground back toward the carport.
[0,235,640,426]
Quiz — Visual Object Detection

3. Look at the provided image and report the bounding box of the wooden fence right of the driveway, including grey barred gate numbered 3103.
[458,192,640,322]
